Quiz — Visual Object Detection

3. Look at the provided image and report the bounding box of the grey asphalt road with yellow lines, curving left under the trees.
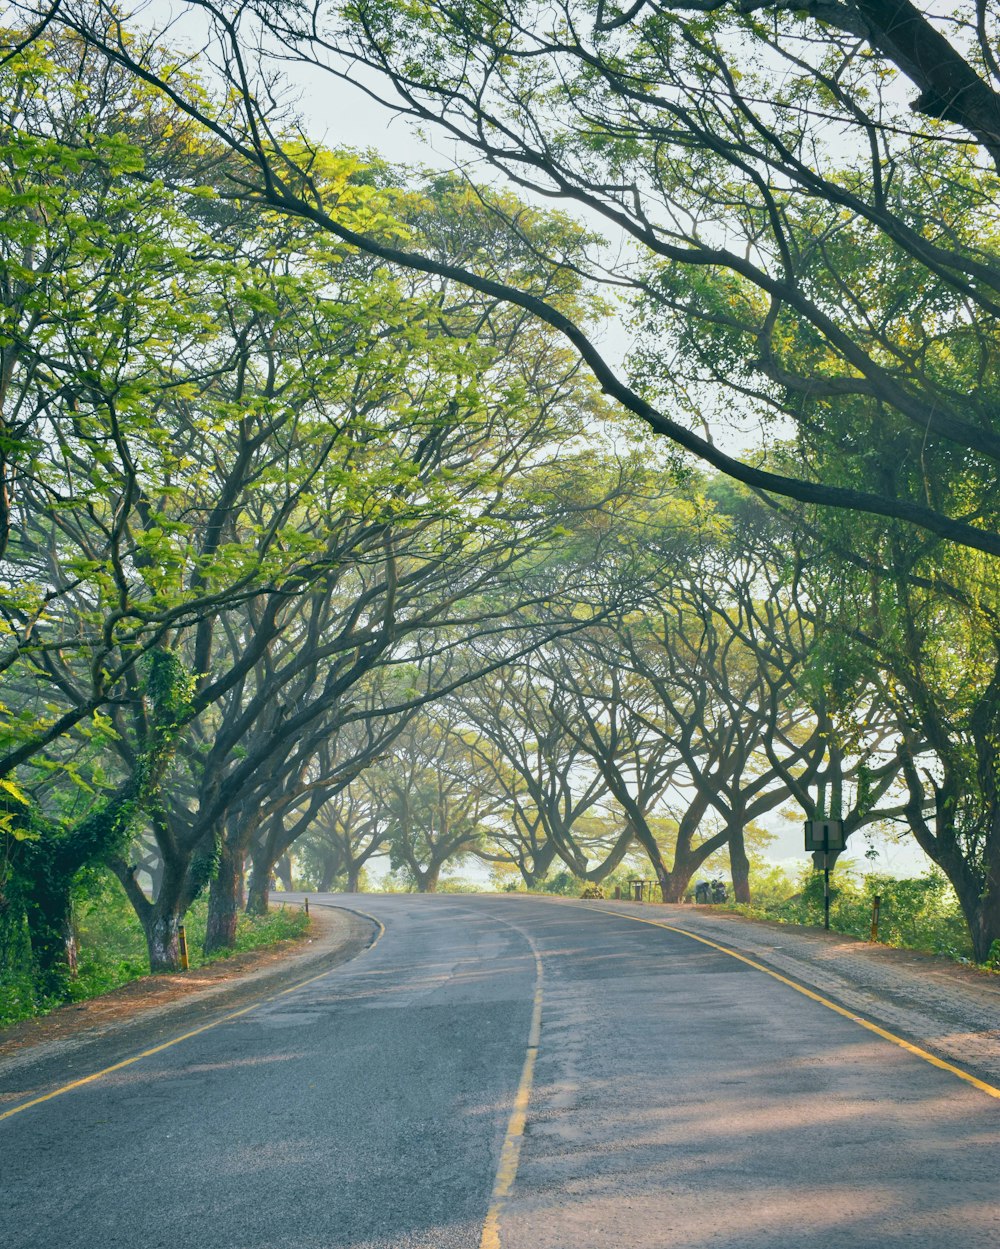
[0,896,1000,1249]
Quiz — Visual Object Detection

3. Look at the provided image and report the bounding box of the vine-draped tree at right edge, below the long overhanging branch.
[794,502,1000,960]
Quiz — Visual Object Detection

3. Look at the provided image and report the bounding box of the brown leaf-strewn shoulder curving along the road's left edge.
[0,906,378,1105]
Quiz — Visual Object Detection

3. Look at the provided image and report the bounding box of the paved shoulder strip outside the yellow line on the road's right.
[574,902,1000,1085]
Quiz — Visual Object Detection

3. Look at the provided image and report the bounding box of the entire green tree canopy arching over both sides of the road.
[0,7,1000,964]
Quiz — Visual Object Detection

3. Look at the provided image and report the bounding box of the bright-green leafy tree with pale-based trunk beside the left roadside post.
[5,124,444,969]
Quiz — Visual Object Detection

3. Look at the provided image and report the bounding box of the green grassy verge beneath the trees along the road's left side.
[0,879,310,1028]
